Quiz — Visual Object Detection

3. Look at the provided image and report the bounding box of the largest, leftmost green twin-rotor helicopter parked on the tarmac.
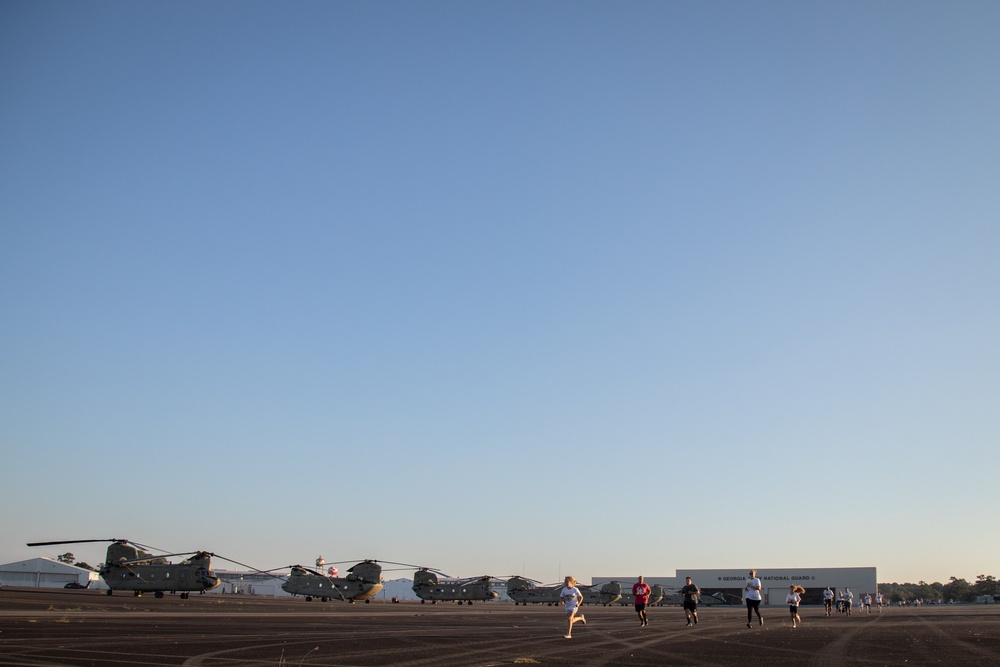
[28,538,219,600]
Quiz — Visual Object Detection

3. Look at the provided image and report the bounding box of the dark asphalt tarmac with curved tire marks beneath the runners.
[0,588,1000,667]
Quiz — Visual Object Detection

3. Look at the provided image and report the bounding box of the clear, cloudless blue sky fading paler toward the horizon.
[0,0,1000,581]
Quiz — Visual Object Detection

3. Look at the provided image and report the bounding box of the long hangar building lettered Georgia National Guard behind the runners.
[591,567,878,605]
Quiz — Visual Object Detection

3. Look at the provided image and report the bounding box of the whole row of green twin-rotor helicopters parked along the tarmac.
[28,538,716,606]
